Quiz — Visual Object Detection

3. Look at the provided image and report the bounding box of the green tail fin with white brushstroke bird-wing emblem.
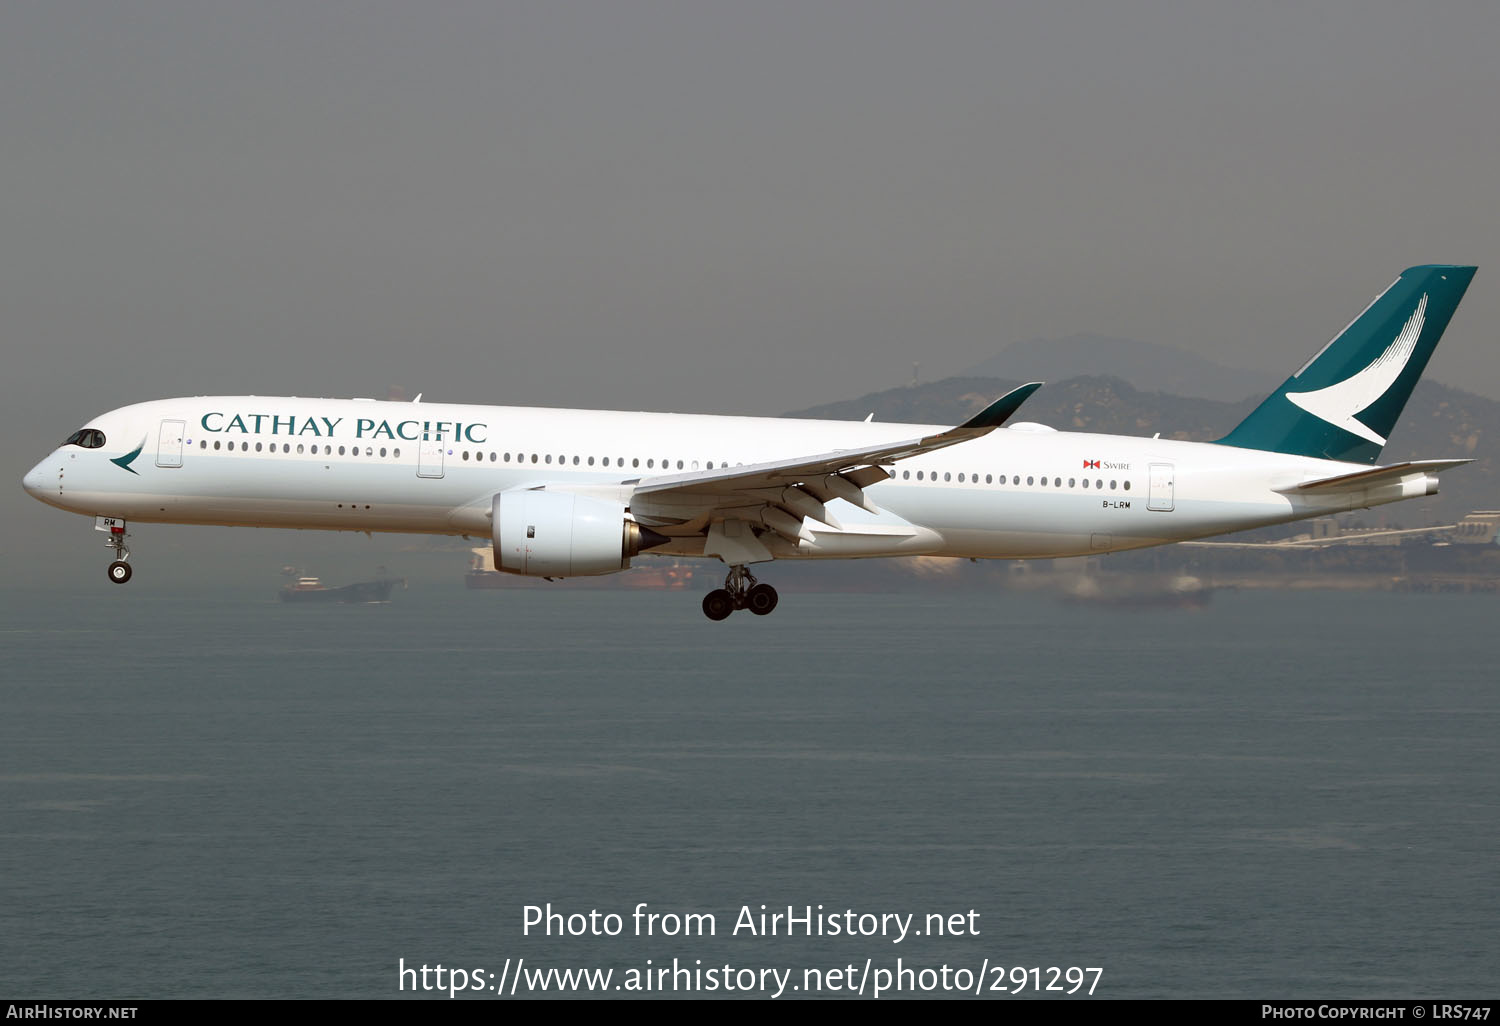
[1218,264,1478,464]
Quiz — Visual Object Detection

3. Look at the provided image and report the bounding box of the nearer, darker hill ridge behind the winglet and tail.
[788,377,1500,527]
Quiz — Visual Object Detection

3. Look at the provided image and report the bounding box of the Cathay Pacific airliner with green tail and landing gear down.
[23,264,1476,621]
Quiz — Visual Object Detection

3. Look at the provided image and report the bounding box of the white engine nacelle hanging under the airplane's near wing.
[491,491,668,578]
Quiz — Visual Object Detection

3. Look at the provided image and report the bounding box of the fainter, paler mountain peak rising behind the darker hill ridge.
[963,335,1286,402]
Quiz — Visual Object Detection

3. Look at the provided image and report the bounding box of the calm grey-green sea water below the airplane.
[0,582,1500,999]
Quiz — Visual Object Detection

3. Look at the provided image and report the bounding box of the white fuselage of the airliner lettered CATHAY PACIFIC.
[14,396,1412,558]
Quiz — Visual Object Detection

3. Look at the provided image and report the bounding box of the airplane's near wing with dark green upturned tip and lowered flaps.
[630,381,1041,560]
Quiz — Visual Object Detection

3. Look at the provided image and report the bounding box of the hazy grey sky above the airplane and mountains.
[0,0,1500,582]
